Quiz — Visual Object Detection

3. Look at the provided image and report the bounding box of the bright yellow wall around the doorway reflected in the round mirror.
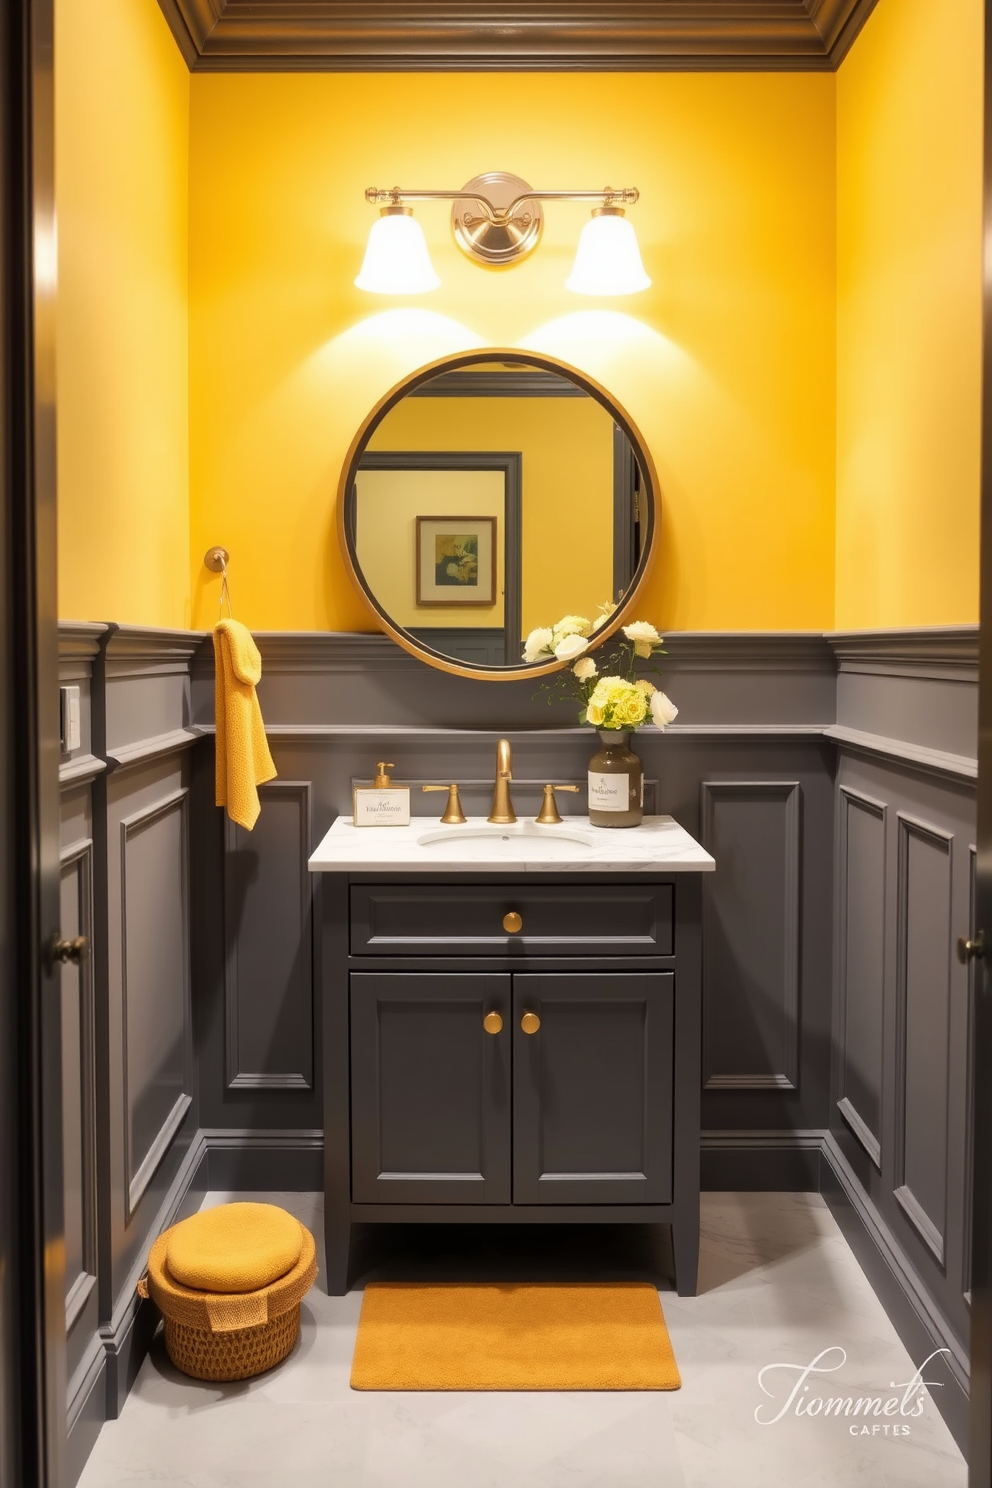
[369,397,616,635]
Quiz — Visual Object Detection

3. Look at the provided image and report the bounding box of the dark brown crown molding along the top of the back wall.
[159,0,876,71]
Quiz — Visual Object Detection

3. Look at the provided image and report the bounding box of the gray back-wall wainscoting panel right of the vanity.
[702,780,802,1091]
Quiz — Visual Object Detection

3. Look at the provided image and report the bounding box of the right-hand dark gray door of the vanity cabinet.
[513,972,675,1204]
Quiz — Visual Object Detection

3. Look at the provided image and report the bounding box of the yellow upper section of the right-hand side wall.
[836,0,983,628]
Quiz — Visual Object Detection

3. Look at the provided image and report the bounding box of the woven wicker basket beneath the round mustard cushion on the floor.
[138,1225,317,1379]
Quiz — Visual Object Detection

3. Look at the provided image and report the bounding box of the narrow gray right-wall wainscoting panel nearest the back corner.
[837,786,886,1167]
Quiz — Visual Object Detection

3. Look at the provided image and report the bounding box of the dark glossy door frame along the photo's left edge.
[0,0,65,1488]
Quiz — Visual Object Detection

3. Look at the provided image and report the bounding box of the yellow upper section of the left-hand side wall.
[55,0,190,626]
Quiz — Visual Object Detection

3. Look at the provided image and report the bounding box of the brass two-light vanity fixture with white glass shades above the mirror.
[355,171,651,295]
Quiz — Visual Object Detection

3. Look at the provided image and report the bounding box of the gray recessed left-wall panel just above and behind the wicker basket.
[119,786,193,1220]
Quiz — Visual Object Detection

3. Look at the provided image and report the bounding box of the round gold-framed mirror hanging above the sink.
[338,351,659,680]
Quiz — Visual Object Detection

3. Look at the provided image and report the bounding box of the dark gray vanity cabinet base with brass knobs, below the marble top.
[321,872,700,1295]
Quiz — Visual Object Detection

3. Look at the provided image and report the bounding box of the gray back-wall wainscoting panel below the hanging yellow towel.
[225,780,314,1091]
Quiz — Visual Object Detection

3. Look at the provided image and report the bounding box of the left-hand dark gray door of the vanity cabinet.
[351,972,512,1204]
